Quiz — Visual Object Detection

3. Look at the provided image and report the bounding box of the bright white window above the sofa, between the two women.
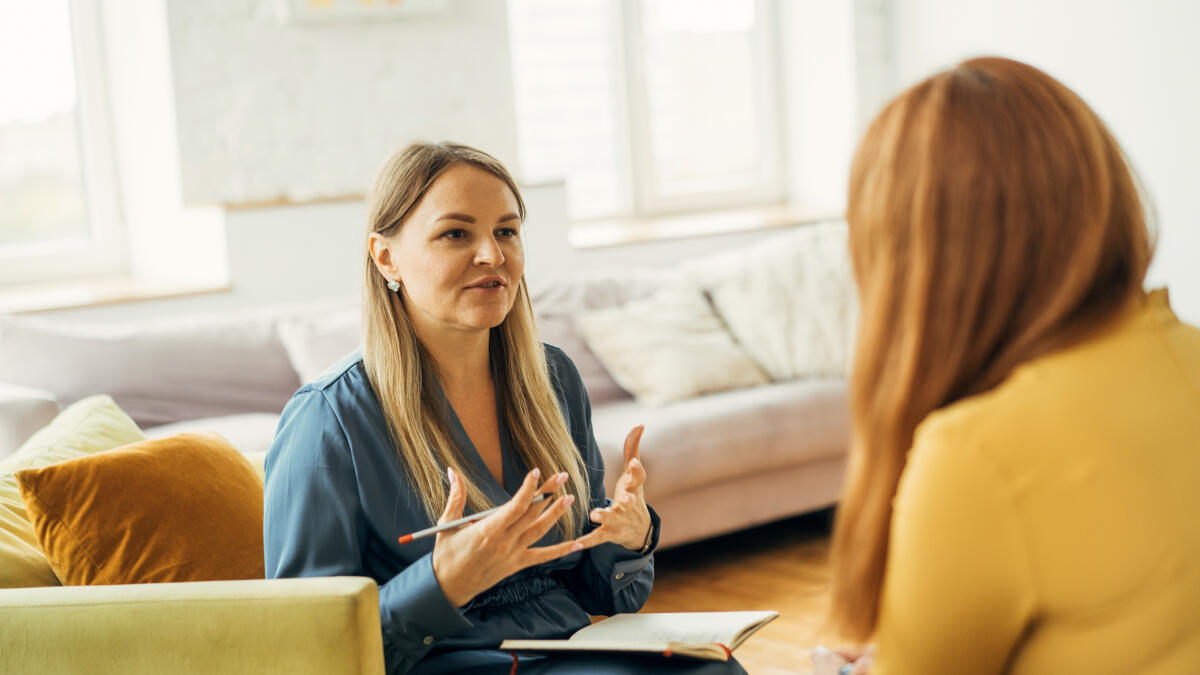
[509,0,784,219]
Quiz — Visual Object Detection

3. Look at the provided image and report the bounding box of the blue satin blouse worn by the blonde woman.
[263,345,659,673]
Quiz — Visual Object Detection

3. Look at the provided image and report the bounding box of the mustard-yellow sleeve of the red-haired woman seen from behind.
[871,415,1036,675]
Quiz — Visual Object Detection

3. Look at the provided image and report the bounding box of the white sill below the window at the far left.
[0,276,230,315]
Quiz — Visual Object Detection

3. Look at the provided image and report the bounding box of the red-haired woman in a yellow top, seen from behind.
[814,59,1200,675]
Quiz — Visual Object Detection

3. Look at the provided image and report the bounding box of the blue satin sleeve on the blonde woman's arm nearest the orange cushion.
[263,390,472,673]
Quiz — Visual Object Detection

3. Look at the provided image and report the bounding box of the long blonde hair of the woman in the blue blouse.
[362,143,590,538]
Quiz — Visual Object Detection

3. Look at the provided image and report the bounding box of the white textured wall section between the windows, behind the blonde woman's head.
[158,0,516,204]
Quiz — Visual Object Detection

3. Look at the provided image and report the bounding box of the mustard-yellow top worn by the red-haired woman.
[871,291,1200,675]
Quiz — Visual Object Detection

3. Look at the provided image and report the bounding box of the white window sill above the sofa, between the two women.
[566,207,842,249]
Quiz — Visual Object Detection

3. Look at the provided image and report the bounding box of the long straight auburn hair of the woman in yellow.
[832,58,1153,640]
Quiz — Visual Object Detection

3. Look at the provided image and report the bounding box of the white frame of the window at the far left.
[0,0,127,287]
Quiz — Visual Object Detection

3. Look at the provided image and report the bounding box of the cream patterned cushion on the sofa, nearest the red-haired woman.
[682,222,857,381]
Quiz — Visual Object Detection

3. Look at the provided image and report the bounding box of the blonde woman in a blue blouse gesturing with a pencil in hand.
[264,143,740,674]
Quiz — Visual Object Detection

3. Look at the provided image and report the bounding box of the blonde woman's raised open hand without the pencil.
[571,425,650,551]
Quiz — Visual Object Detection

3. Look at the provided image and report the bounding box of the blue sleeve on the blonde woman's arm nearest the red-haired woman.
[550,347,661,615]
